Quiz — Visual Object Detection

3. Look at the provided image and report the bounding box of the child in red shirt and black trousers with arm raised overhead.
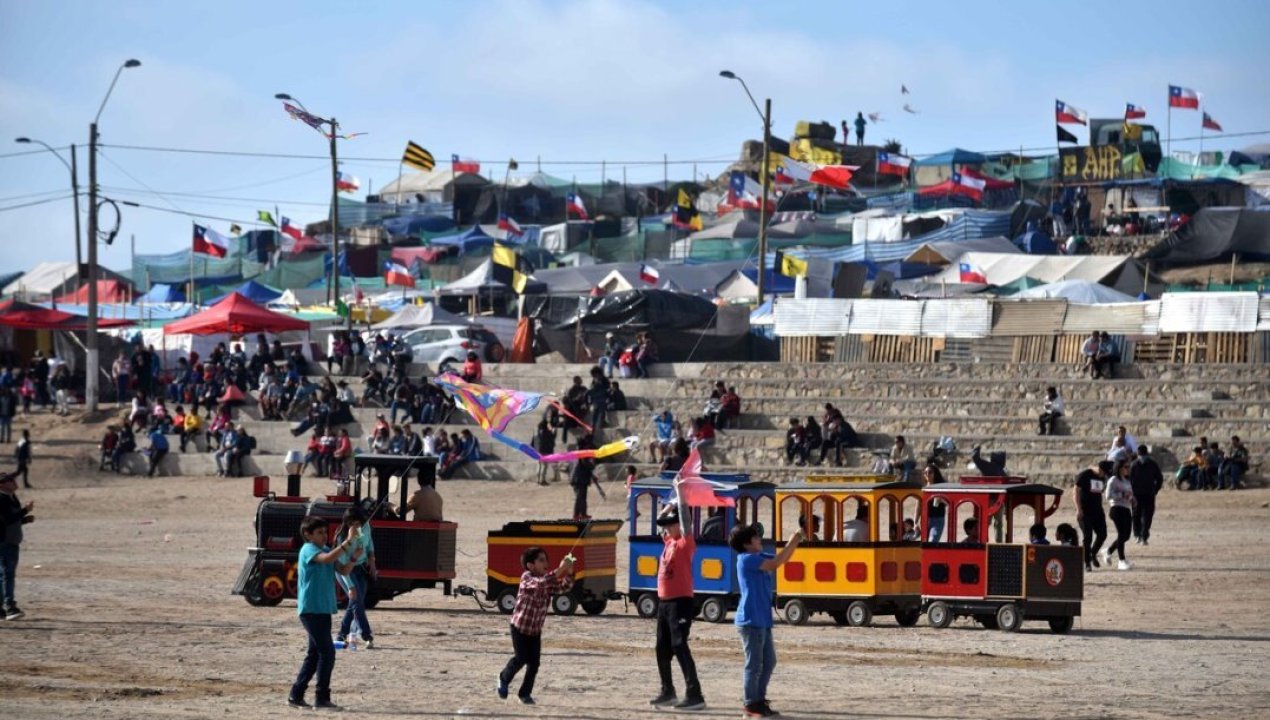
[649,480,706,710]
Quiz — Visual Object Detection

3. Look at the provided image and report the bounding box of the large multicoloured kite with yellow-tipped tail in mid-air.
[433,372,639,462]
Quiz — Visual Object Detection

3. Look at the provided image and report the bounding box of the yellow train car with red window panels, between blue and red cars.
[776,475,922,627]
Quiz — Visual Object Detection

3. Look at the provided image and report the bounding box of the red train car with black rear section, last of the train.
[922,476,1085,634]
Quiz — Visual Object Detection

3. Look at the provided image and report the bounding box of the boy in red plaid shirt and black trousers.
[498,546,573,705]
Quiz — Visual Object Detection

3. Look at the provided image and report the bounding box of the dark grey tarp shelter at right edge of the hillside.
[1143,207,1270,265]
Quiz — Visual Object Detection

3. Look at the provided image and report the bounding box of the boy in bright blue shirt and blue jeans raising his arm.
[728,526,803,717]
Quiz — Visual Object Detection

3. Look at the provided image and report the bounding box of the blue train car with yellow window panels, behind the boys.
[627,472,776,622]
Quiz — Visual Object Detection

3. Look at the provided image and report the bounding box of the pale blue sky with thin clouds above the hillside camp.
[0,0,1270,273]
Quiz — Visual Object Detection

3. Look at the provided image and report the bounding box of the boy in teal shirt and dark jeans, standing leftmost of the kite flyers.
[287,516,362,710]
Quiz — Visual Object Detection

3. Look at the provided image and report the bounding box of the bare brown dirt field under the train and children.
[0,413,1270,720]
